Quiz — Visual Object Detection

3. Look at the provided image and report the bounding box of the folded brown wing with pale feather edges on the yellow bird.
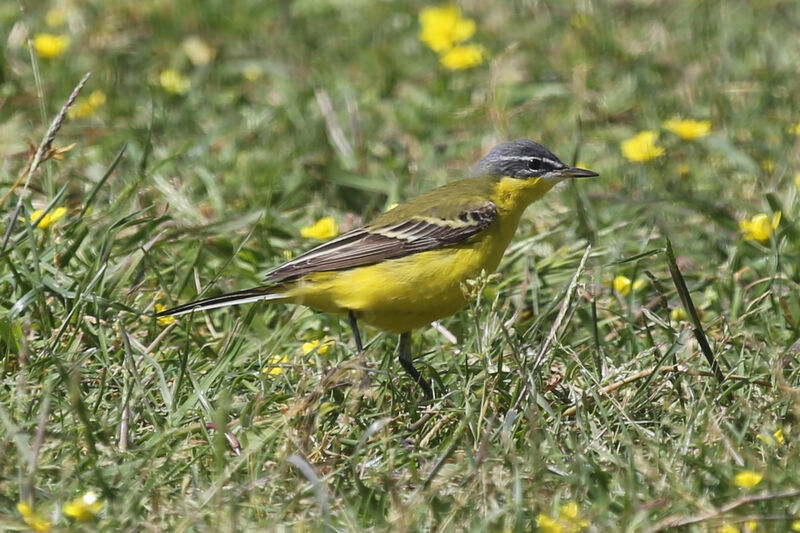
[264,202,497,282]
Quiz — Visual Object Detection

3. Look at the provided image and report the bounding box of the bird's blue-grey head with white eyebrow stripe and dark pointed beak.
[472,139,597,179]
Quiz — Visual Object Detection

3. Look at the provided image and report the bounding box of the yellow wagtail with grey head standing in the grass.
[158,139,598,398]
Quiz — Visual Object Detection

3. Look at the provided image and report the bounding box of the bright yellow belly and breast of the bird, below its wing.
[284,229,508,333]
